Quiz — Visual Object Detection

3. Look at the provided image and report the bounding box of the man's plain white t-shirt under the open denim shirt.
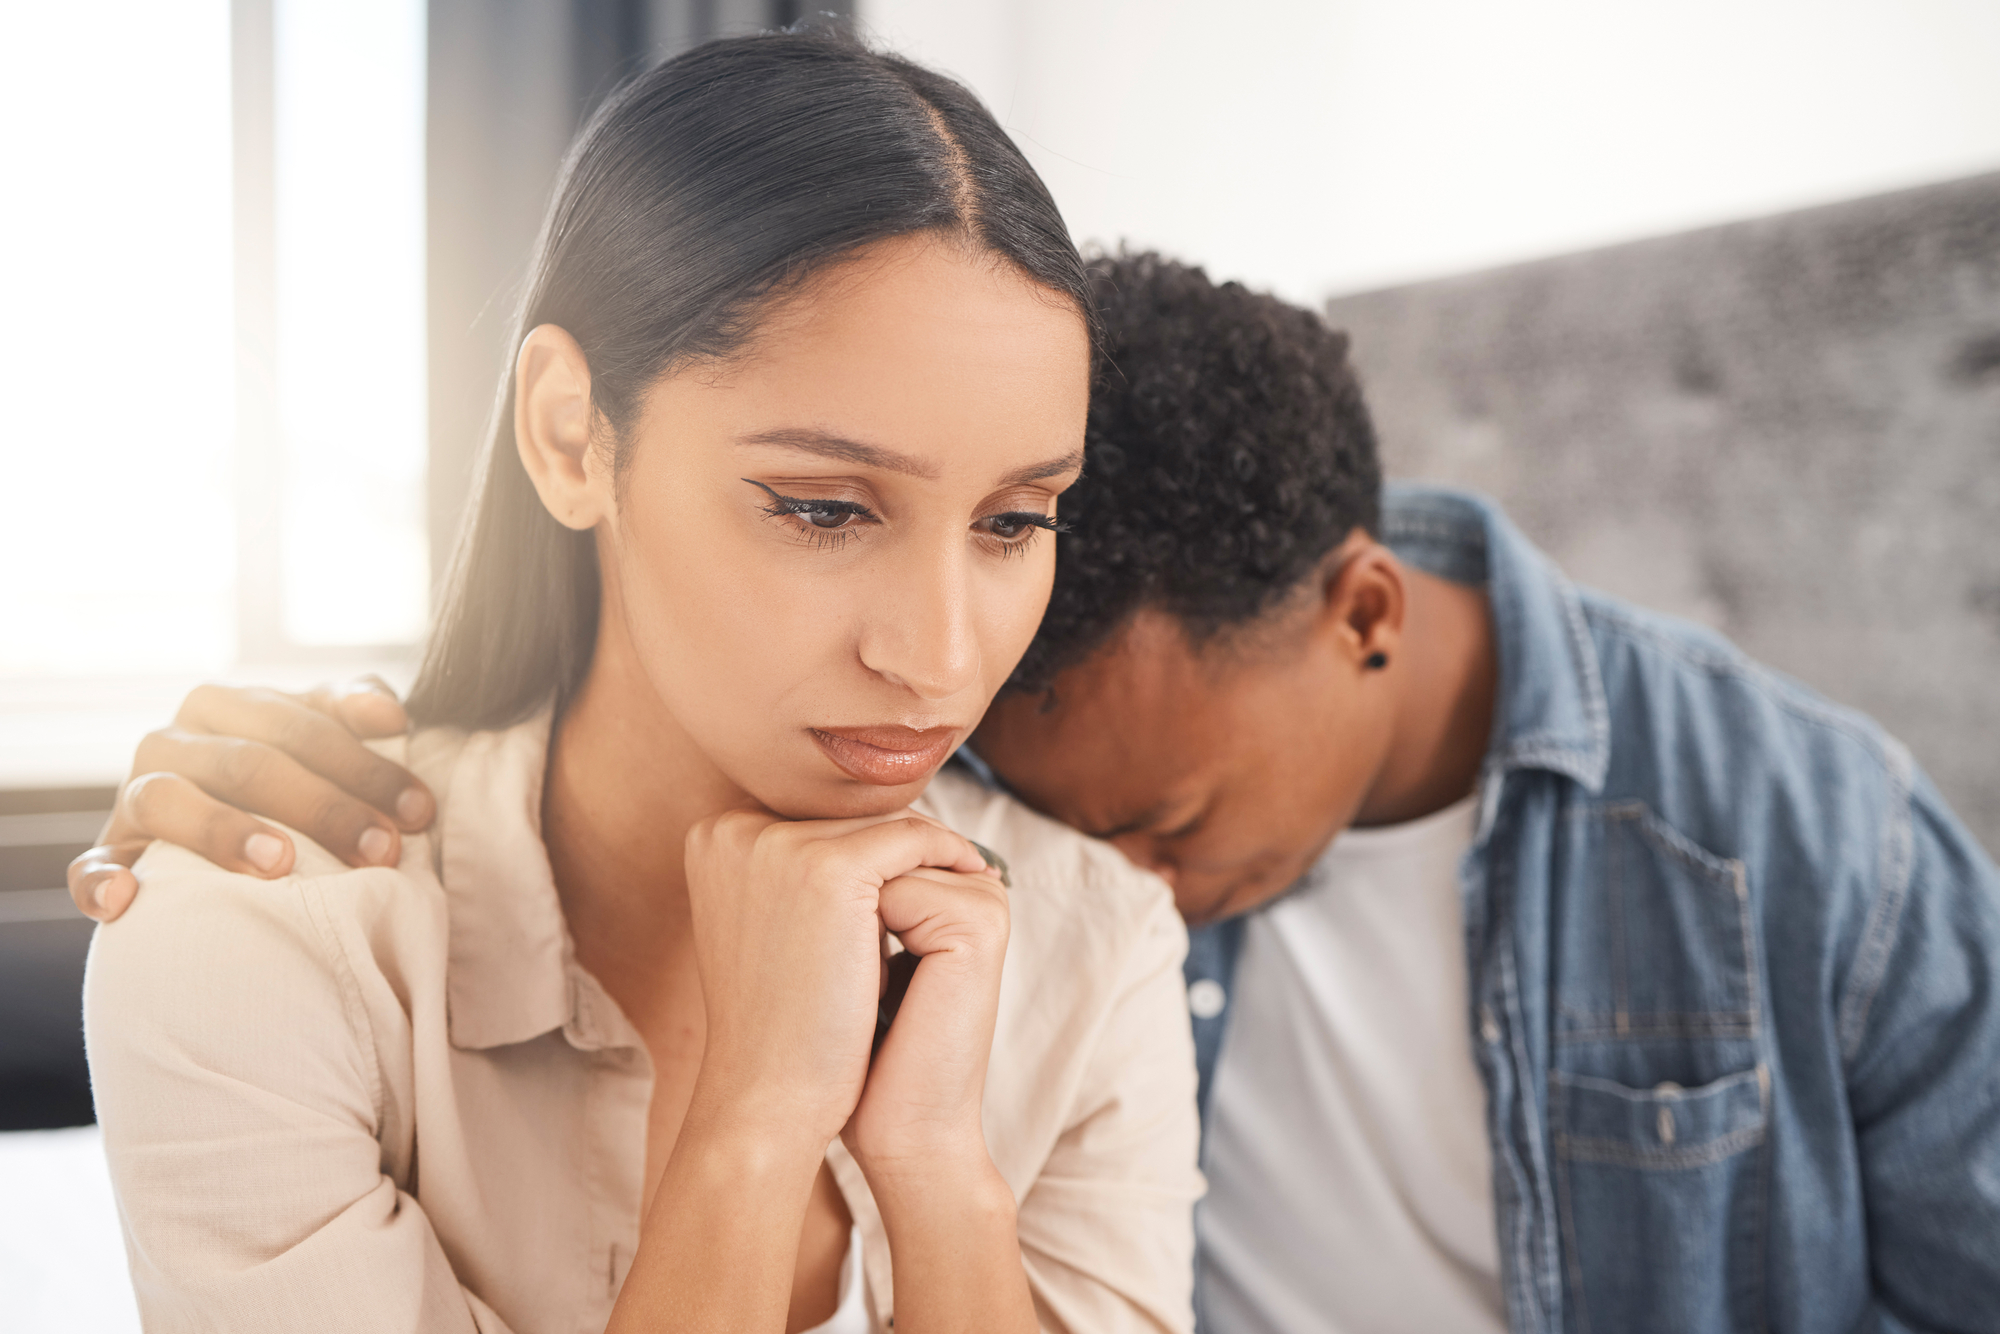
[1196,798,1506,1334]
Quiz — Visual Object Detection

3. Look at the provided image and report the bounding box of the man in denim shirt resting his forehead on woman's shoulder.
[72,256,2000,1334]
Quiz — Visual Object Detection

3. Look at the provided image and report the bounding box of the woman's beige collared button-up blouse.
[84,716,1202,1334]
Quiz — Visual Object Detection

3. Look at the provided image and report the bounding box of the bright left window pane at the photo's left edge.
[0,0,236,676]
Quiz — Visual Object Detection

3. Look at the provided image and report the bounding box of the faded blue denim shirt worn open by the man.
[1186,488,2000,1334]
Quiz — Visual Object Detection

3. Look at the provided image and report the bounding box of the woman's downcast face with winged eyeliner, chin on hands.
[524,238,1090,816]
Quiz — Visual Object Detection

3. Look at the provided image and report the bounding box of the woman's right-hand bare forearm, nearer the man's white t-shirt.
[862,1144,1036,1334]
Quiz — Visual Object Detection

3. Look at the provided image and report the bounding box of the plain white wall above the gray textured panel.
[860,0,2000,302]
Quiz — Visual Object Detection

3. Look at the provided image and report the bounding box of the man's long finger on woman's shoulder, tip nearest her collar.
[169,686,438,824]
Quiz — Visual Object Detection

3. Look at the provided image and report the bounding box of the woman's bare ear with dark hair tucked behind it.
[514,324,610,532]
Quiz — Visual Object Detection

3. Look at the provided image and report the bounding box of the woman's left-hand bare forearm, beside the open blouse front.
[606,1108,826,1334]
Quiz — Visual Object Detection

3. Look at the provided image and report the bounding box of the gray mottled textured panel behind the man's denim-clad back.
[1328,174,2000,852]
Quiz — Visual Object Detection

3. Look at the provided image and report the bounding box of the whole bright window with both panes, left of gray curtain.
[0,0,430,786]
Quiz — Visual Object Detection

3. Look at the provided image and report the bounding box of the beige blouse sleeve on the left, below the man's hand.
[84,846,506,1334]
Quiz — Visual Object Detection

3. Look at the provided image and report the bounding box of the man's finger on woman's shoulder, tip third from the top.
[124,730,402,874]
